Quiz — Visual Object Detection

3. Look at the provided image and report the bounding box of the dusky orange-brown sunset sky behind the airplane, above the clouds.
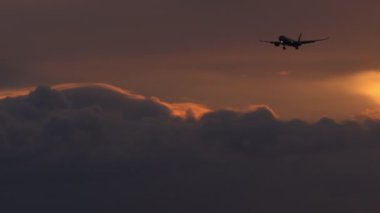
[0,0,380,120]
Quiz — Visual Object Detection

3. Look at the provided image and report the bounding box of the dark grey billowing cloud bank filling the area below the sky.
[0,86,380,212]
